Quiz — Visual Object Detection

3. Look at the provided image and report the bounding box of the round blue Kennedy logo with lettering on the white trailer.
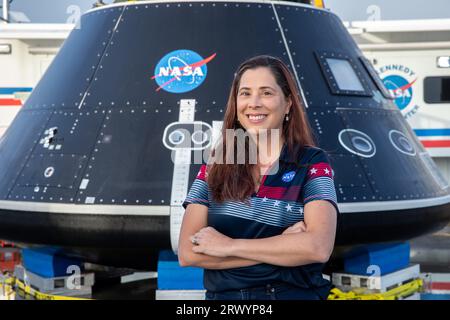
[379,64,419,118]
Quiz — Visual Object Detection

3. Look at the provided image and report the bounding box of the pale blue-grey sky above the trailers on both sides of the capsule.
[5,0,450,23]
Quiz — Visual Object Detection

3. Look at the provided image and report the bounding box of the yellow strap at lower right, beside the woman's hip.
[328,279,423,300]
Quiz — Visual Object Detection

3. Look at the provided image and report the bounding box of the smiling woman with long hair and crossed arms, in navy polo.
[178,56,338,300]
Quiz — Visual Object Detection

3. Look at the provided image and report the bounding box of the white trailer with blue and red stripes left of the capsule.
[0,23,70,137]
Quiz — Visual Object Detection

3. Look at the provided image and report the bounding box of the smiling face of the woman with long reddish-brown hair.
[237,67,292,135]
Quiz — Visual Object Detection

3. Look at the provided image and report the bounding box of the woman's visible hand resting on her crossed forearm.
[191,227,233,258]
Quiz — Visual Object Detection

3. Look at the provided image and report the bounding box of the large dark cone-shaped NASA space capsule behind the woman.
[0,1,450,267]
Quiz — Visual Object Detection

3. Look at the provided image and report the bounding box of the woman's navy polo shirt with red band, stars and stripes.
[183,144,338,298]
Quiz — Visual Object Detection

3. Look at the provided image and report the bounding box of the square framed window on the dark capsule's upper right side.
[316,52,372,97]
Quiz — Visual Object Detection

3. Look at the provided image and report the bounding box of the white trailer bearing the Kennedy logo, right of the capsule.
[347,19,450,180]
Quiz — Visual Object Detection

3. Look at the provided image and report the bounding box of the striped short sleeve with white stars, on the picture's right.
[302,149,339,212]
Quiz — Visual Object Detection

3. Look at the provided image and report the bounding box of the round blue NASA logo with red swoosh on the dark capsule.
[152,49,216,93]
